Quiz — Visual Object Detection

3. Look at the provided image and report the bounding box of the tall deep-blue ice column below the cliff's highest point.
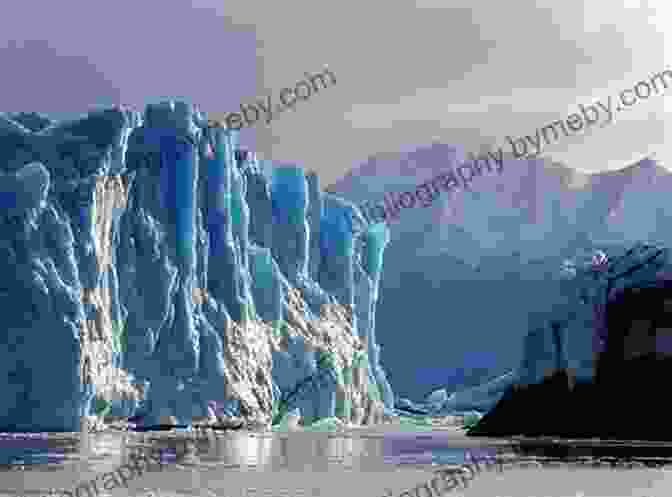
[119,102,203,423]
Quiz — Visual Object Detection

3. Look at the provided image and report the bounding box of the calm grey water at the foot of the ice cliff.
[0,430,672,497]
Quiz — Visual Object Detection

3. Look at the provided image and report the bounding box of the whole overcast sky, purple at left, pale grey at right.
[0,0,672,185]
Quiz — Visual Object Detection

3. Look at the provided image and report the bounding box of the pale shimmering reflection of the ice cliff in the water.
[0,431,444,472]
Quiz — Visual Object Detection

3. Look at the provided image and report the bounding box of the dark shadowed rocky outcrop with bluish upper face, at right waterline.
[469,244,672,440]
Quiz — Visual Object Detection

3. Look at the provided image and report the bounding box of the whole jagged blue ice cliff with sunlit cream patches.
[0,102,393,432]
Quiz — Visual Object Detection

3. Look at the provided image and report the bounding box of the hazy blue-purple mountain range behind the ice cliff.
[328,143,672,400]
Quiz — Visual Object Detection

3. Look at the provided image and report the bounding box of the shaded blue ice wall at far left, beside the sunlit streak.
[0,109,134,431]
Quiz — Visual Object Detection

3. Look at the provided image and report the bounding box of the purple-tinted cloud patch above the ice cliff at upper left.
[0,0,257,140]
